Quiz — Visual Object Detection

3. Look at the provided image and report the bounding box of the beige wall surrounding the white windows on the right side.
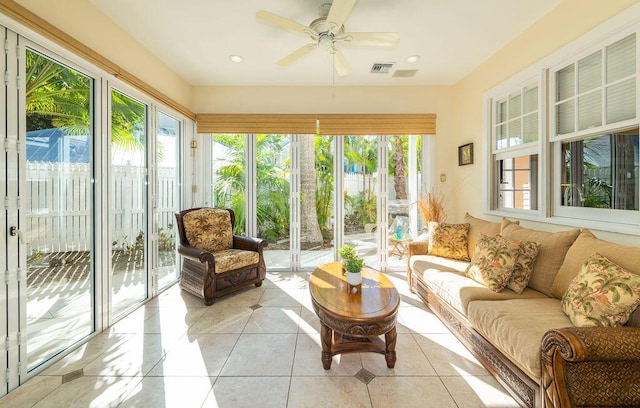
[448,0,640,245]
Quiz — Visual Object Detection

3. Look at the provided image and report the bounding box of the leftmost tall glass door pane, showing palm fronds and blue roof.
[20,49,95,371]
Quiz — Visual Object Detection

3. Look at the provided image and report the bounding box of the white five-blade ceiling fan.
[256,0,400,77]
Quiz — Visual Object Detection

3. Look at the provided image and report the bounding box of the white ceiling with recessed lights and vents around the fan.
[91,0,562,86]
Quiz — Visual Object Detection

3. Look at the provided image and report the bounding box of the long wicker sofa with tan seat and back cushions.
[408,214,640,407]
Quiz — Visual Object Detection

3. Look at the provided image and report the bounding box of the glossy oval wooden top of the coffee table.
[309,262,400,321]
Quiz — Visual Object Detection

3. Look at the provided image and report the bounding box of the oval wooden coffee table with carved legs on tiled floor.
[309,262,400,370]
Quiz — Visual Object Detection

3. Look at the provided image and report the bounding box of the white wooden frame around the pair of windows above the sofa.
[483,4,640,235]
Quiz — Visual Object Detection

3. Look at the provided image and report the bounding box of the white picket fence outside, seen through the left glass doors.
[23,162,178,254]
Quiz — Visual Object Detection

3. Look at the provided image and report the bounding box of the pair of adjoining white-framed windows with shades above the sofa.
[485,23,640,233]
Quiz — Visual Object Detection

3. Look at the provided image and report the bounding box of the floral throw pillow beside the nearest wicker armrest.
[562,252,640,327]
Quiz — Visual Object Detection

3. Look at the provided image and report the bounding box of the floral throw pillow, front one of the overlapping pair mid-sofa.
[466,235,522,292]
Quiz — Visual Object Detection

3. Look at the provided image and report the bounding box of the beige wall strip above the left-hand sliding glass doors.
[15,0,191,108]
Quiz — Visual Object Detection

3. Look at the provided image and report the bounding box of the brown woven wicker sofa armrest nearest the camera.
[541,327,640,407]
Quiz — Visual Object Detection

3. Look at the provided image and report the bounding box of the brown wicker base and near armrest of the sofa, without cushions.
[407,246,640,408]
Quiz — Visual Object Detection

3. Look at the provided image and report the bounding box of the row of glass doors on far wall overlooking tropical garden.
[211,134,422,270]
